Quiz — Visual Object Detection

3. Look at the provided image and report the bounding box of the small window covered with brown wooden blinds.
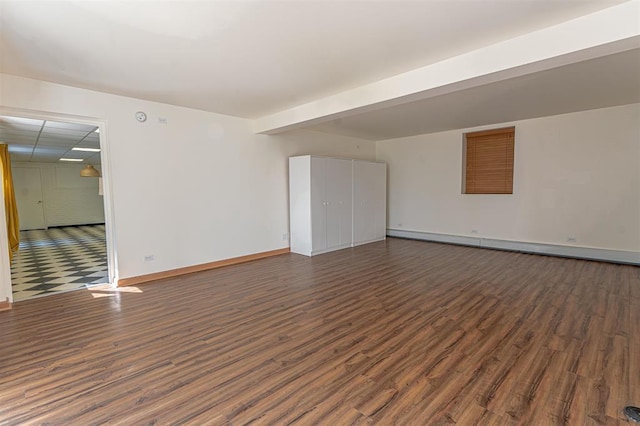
[462,127,515,194]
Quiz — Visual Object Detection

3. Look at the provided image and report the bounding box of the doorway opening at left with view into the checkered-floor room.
[0,113,116,302]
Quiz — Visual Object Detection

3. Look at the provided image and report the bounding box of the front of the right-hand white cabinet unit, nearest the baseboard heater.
[353,161,387,244]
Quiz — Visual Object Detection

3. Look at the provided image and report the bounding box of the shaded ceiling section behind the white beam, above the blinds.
[308,49,640,140]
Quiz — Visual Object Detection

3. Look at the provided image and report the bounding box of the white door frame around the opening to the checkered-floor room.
[0,106,119,303]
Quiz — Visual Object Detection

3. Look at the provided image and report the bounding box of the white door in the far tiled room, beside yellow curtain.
[12,167,45,231]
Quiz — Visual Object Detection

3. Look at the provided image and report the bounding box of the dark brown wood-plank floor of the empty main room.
[0,239,640,425]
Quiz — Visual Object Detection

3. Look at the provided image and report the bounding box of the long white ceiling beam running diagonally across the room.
[253,0,640,134]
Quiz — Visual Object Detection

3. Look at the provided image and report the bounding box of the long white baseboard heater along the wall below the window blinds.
[387,228,640,265]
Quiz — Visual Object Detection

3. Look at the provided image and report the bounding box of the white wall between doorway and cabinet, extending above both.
[0,74,375,292]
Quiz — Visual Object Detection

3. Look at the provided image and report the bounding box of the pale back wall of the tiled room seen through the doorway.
[12,162,104,227]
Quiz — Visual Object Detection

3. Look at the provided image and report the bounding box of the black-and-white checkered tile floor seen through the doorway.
[11,225,109,301]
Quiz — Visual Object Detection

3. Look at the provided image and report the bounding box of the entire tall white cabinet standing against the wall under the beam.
[289,155,386,256]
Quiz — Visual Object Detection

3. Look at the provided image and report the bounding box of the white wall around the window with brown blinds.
[377,104,640,252]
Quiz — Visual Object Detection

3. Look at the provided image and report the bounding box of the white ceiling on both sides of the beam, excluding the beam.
[0,0,640,140]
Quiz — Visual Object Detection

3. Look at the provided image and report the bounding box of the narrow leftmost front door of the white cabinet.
[310,157,327,251]
